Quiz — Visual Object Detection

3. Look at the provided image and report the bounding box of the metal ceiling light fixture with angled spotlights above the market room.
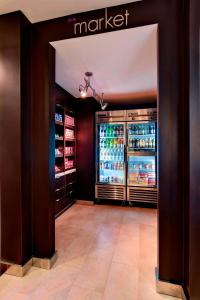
[79,72,108,110]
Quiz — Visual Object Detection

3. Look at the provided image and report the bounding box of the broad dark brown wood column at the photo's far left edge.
[0,12,32,265]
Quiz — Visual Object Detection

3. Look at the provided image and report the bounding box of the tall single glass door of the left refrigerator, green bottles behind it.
[97,123,126,185]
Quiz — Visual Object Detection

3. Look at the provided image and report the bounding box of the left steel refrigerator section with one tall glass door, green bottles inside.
[95,111,126,200]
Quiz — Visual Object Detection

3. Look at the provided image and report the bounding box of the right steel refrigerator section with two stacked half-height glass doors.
[127,109,157,203]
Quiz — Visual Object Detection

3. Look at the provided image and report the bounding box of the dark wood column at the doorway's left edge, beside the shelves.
[31,31,55,258]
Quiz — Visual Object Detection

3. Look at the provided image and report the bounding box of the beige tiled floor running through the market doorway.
[0,205,180,300]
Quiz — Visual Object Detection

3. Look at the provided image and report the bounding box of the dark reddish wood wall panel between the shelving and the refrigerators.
[76,99,97,201]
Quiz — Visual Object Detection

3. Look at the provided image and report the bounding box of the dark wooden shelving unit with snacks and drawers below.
[55,105,76,217]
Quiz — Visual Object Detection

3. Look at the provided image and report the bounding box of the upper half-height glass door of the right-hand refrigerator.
[127,122,157,152]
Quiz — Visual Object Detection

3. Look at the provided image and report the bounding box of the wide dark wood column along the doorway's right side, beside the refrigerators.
[158,1,188,284]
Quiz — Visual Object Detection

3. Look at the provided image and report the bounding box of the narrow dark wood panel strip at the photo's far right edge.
[188,0,200,300]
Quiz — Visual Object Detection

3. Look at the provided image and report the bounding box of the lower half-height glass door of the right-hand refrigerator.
[128,155,156,187]
